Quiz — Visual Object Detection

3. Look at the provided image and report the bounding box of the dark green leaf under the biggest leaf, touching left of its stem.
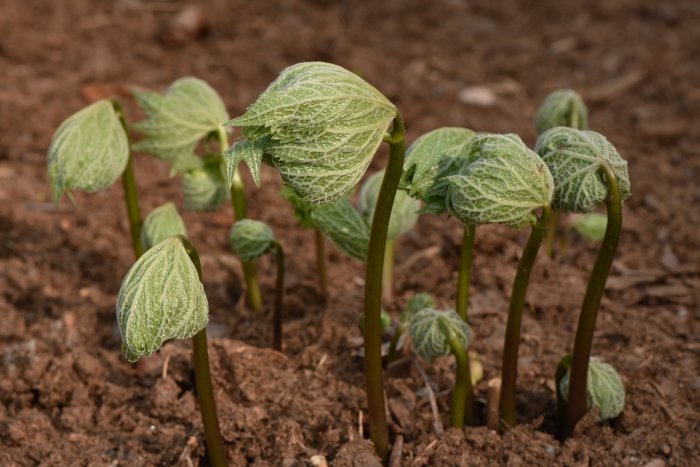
[311,198,369,261]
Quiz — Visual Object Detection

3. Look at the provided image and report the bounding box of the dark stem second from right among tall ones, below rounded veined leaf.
[499,206,551,428]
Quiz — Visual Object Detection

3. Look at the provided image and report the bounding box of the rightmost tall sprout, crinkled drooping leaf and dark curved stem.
[535,127,630,435]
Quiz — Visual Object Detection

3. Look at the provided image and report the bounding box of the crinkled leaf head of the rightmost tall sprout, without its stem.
[535,127,630,212]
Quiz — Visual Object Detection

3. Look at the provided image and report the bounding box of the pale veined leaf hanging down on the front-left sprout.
[117,237,209,362]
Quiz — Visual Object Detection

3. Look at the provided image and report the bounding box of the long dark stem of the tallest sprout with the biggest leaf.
[365,112,405,459]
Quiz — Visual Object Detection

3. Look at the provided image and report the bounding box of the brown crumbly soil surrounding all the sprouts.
[0,0,700,467]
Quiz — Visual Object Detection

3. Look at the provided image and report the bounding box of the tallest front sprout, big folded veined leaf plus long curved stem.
[225,62,404,458]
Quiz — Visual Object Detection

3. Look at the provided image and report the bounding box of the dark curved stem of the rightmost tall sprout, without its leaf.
[565,162,622,436]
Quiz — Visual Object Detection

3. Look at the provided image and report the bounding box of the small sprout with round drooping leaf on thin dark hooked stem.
[229,219,284,352]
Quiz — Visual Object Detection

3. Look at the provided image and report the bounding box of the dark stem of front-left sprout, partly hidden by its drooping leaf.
[179,235,228,467]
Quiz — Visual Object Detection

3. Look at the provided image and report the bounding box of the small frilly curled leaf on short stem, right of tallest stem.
[408,308,470,362]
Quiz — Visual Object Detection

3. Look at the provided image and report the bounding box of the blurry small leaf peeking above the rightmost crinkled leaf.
[535,89,588,135]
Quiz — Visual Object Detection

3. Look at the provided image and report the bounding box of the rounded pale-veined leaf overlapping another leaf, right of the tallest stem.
[448,134,554,229]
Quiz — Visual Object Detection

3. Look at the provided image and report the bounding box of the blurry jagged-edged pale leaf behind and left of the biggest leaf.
[133,77,229,174]
